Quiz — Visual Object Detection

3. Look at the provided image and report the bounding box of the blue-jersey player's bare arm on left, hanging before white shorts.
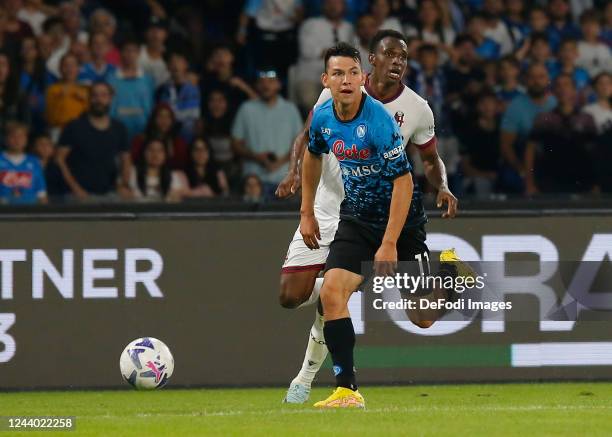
[300,151,322,249]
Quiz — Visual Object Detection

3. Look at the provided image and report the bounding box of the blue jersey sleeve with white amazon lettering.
[373,111,412,180]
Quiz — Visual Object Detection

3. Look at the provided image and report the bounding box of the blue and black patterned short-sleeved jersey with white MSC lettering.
[308,93,412,227]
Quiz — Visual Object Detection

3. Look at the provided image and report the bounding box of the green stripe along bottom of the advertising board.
[324,345,512,369]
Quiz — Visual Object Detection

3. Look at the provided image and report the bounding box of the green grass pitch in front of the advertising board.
[0,383,612,437]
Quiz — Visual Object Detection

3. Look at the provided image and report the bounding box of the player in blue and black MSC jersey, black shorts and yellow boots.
[300,43,414,408]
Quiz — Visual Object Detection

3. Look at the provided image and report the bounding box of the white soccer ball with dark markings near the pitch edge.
[119,337,174,390]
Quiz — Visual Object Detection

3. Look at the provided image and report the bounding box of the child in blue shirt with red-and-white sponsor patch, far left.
[0,122,47,204]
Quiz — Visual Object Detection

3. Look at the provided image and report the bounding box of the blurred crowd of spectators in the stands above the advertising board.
[0,0,612,204]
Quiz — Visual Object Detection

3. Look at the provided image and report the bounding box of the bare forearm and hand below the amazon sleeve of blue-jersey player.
[374,173,414,275]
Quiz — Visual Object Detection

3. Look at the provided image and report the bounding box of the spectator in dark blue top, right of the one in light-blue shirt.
[157,52,201,143]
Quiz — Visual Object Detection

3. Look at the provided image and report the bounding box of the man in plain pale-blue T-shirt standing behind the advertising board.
[232,71,303,190]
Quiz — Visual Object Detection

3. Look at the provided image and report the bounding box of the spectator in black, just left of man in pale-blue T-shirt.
[204,90,242,192]
